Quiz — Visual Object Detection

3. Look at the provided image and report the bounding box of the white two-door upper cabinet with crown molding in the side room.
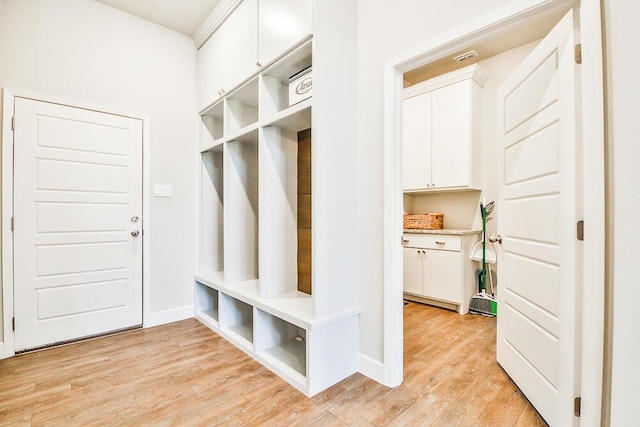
[403,65,486,192]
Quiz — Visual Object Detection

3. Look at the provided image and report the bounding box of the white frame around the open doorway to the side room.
[379,0,607,425]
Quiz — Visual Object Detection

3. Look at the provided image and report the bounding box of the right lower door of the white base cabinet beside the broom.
[422,249,462,304]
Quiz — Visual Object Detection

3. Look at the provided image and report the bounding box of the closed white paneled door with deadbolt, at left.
[13,97,142,351]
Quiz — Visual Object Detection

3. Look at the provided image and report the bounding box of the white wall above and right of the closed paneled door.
[0,0,199,332]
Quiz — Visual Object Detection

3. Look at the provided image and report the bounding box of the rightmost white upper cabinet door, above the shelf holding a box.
[258,0,313,65]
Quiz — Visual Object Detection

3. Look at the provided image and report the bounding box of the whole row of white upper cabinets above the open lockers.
[198,0,313,111]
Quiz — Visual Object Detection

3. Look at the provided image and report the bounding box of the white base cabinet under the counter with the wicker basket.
[403,231,478,314]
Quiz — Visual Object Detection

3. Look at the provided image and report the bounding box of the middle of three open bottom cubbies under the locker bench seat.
[219,293,253,349]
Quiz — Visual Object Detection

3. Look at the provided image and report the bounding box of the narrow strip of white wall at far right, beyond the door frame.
[604,0,640,426]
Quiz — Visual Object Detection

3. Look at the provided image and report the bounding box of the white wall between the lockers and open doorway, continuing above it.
[357,0,535,362]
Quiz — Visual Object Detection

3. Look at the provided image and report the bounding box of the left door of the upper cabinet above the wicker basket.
[402,92,431,190]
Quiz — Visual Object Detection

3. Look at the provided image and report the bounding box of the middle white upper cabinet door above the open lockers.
[214,0,258,92]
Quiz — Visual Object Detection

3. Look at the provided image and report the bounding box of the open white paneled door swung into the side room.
[497,11,581,426]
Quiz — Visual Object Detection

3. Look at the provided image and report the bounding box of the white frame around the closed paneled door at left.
[0,88,151,359]
